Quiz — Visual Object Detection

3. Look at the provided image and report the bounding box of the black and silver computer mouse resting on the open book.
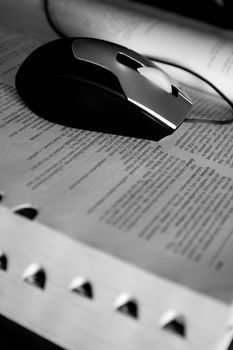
[15,37,192,141]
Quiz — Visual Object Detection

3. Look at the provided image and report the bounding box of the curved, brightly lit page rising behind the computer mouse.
[47,0,233,99]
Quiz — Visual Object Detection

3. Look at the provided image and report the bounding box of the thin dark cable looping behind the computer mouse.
[43,0,233,125]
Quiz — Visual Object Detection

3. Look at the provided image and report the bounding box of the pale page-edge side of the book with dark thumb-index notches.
[0,208,229,350]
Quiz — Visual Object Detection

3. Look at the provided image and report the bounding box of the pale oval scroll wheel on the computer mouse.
[137,67,173,93]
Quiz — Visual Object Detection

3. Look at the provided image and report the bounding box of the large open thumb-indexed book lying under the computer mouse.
[0,0,233,350]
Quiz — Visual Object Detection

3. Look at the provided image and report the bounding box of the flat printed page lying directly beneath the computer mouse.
[0,21,233,302]
